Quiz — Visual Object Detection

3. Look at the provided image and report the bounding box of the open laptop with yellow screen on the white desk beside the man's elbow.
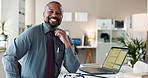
[79,47,129,74]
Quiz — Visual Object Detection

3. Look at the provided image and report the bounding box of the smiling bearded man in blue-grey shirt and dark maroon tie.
[3,1,80,78]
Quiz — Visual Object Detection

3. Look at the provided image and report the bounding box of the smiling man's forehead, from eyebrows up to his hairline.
[46,3,63,11]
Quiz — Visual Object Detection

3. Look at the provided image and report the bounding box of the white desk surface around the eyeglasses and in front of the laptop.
[58,66,132,78]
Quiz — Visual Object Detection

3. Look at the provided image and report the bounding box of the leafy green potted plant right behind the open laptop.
[118,33,146,67]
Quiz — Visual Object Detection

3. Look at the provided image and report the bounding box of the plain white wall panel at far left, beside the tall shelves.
[0,0,19,43]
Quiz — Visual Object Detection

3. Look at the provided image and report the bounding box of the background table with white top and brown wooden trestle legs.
[76,46,96,64]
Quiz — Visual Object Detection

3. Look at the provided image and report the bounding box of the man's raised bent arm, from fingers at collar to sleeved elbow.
[55,29,80,73]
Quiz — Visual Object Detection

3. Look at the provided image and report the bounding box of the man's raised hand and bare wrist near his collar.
[55,29,70,49]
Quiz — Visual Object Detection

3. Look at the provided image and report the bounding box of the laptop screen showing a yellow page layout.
[102,47,128,72]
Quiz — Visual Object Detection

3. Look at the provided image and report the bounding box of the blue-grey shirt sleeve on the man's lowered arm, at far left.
[2,29,31,78]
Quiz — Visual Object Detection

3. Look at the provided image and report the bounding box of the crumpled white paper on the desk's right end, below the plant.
[133,61,148,73]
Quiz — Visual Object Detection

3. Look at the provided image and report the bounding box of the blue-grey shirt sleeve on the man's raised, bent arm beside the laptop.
[64,36,80,73]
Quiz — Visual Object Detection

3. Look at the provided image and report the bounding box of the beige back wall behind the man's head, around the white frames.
[35,0,147,38]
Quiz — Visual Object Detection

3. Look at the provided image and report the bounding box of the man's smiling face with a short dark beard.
[43,3,63,28]
